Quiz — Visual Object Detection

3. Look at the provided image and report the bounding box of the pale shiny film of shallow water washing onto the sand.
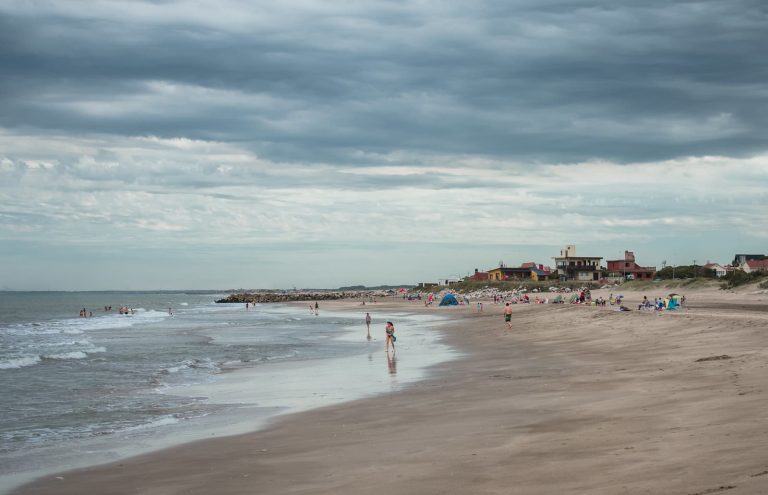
[0,303,453,494]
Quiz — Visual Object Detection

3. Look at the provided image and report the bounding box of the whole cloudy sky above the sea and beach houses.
[0,0,768,290]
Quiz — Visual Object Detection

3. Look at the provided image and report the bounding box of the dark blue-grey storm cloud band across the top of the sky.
[0,0,768,164]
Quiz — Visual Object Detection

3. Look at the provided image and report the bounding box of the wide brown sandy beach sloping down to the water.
[14,290,768,495]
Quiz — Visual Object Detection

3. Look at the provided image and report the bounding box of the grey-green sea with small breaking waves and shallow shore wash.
[0,292,455,492]
